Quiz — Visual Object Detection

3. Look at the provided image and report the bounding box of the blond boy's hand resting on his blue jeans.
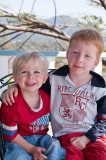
[30,146,47,160]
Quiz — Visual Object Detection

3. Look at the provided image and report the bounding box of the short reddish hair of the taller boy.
[68,29,104,59]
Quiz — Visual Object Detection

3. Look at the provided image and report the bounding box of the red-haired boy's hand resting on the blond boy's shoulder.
[2,84,18,105]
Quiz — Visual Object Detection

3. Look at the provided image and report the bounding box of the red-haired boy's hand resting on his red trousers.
[70,135,91,150]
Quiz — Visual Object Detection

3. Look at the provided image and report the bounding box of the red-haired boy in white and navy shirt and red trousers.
[3,29,106,160]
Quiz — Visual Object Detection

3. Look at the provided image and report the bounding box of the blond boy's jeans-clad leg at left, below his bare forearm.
[4,142,32,160]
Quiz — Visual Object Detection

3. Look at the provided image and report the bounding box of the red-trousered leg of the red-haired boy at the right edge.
[84,138,106,160]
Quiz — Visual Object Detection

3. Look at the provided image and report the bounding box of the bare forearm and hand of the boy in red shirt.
[11,134,47,160]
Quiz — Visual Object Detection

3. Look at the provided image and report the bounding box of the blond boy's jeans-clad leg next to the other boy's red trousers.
[38,135,65,160]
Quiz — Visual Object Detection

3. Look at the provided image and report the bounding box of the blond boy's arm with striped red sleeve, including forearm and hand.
[0,103,47,160]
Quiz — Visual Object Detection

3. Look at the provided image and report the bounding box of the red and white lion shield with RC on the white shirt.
[59,94,88,123]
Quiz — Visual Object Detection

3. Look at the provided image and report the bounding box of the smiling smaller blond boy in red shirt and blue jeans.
[1,52,65,160]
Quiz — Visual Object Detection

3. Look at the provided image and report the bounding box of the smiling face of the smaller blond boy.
[13,59,48,93]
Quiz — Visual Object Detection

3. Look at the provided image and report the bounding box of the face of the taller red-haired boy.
[67,40,98,76]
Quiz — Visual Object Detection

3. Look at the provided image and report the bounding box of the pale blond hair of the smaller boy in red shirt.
[12,52,49,76]
